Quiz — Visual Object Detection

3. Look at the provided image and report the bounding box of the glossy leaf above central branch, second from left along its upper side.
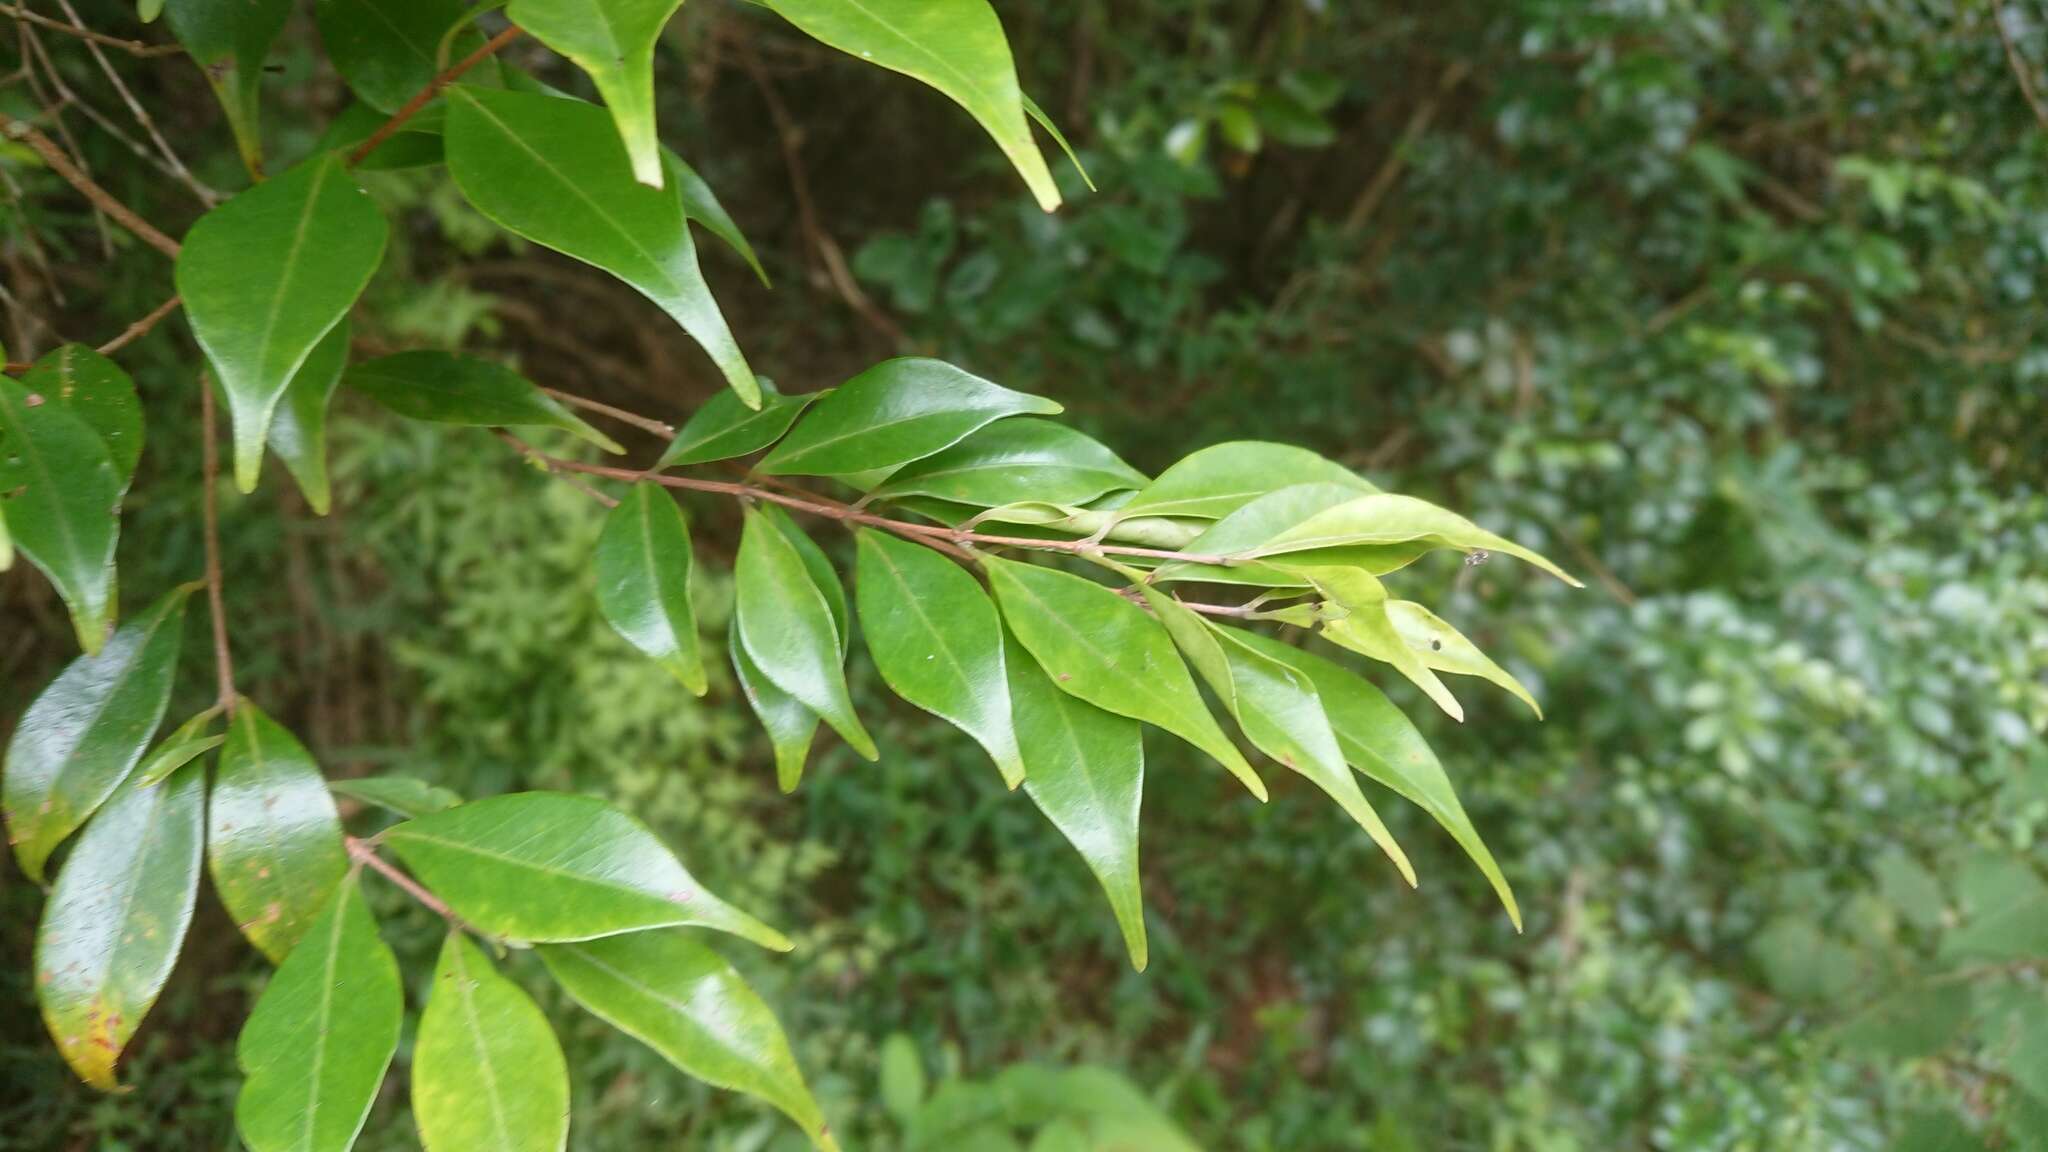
[870,416,1147,508]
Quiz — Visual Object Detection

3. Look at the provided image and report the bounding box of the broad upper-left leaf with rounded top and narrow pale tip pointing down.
[176,154,391,492]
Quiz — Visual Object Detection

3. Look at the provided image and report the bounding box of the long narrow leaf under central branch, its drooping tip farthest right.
[1237,631,1522,931]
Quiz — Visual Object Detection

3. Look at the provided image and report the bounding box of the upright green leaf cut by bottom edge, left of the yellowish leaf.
[236,875,406,1152]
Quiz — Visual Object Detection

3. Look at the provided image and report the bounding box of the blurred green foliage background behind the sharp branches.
[0,0,2048,1152]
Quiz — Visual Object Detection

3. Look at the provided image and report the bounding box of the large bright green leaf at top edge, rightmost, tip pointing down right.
[762,0,1059,211]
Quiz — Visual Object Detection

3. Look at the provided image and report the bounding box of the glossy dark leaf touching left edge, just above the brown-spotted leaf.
[0,586,193,883]
